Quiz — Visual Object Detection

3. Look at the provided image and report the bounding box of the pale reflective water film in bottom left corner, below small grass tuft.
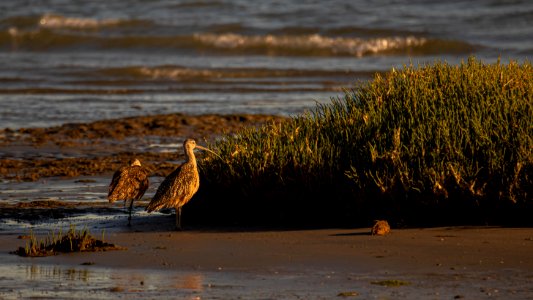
[0,264,205,299]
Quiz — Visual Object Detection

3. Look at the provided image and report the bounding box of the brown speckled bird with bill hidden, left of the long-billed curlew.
[107,159,150,226]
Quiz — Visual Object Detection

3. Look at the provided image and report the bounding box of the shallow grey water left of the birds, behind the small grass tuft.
[0,176,166,235]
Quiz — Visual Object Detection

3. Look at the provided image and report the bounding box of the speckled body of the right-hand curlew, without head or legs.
[146,162,200,212]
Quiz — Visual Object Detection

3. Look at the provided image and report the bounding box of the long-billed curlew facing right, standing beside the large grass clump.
[146,139,214,230]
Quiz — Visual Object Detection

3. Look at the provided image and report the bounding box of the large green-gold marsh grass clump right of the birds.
[197,57,533,223]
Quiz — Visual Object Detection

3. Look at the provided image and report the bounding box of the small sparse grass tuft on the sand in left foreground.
[13,225,124,257]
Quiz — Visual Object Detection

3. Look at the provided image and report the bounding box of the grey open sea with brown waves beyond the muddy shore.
[0,0,533,128]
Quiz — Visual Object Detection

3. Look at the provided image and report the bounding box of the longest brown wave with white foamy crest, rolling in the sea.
[0,27,474,57]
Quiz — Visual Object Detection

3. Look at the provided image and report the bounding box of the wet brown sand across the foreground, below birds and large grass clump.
[0,220,533,299]
